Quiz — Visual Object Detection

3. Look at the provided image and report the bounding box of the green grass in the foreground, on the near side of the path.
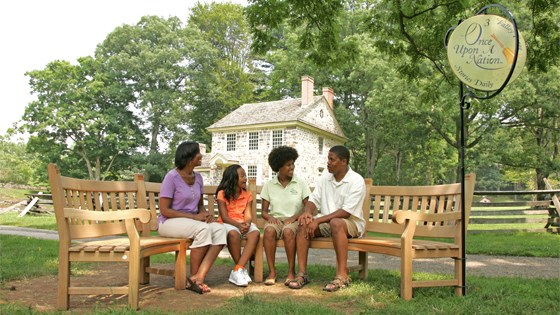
[0,236,560,315]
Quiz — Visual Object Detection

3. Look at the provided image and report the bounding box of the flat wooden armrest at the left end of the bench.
[64,208,151,223]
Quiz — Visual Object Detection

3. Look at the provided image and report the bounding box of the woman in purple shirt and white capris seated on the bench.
[158,141,227,294]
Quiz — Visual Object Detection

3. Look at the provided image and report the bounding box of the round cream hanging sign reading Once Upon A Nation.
[447,15,527,91]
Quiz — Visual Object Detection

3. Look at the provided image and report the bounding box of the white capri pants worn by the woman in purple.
[158,218,227,248]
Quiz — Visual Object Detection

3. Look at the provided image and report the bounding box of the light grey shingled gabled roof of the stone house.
[207,95,346,138]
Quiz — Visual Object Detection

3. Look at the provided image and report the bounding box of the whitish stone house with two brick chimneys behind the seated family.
[196,76,347,187]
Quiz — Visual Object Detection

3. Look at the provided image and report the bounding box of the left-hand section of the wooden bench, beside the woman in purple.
[48,164,190,309]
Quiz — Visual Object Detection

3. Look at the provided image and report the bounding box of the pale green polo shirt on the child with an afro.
[261,176,311,218]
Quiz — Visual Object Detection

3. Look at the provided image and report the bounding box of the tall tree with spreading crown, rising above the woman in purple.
[95,16,200,153]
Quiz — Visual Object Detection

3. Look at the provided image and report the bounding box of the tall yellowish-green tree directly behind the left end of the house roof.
[188,3,259,144]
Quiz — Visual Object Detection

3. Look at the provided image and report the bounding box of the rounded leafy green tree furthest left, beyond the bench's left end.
[22,57,143,179]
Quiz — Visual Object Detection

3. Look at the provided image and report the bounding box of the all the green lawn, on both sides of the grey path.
[0,206,560,315]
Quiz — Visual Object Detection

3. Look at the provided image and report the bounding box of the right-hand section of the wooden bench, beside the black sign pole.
[255,174,476,300]
